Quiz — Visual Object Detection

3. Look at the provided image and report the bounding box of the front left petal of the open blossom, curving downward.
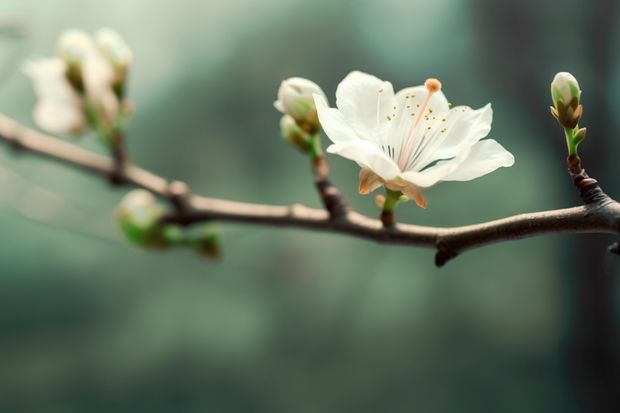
[327,140,400,181]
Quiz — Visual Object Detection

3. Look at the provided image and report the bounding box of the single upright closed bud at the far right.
[551,72,583,129]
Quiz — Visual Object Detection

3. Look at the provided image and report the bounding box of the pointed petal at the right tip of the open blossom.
[442,139,515,181]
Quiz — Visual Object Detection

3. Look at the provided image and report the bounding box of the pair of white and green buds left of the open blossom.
[273,77,325,153]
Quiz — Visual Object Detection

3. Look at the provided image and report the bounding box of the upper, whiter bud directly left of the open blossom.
[273,77,325,133]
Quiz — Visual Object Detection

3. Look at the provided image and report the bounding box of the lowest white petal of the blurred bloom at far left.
[33,100,86,133]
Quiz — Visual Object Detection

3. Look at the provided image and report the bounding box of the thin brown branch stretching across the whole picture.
[0,114,620,266]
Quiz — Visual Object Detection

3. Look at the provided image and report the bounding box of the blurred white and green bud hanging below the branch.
[116,189,167,247]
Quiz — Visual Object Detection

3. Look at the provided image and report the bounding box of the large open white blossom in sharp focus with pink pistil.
[314,72,514,207]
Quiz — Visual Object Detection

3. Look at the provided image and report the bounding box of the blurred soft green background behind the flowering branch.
[0,0,620,413]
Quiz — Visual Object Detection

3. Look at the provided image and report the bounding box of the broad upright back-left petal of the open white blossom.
[336,71,398,140]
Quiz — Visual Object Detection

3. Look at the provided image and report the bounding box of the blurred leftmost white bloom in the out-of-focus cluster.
[23,58,86,133]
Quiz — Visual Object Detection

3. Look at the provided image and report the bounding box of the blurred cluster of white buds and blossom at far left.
[24,29,132,142]
